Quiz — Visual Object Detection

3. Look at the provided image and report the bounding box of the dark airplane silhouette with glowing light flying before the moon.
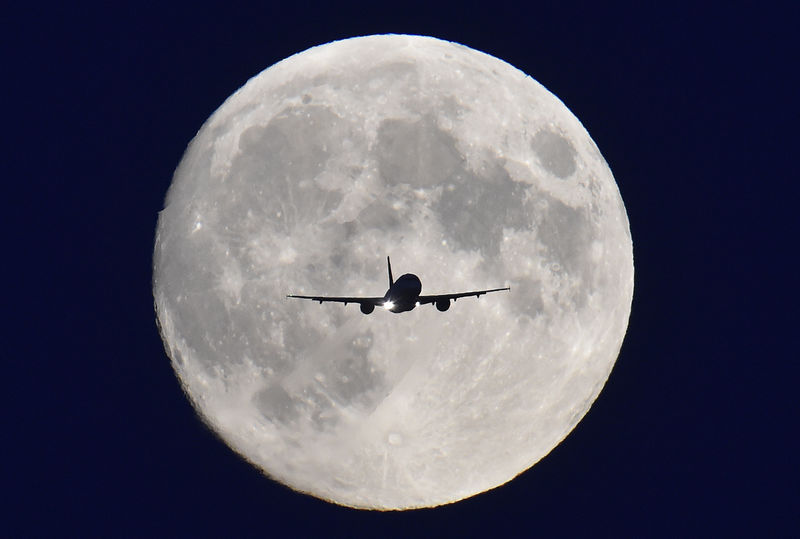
[286,256,511,314]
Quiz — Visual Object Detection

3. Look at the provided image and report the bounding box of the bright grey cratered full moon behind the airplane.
[154,35,633,509]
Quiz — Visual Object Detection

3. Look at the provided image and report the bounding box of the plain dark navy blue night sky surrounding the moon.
[0,2,800,537]
